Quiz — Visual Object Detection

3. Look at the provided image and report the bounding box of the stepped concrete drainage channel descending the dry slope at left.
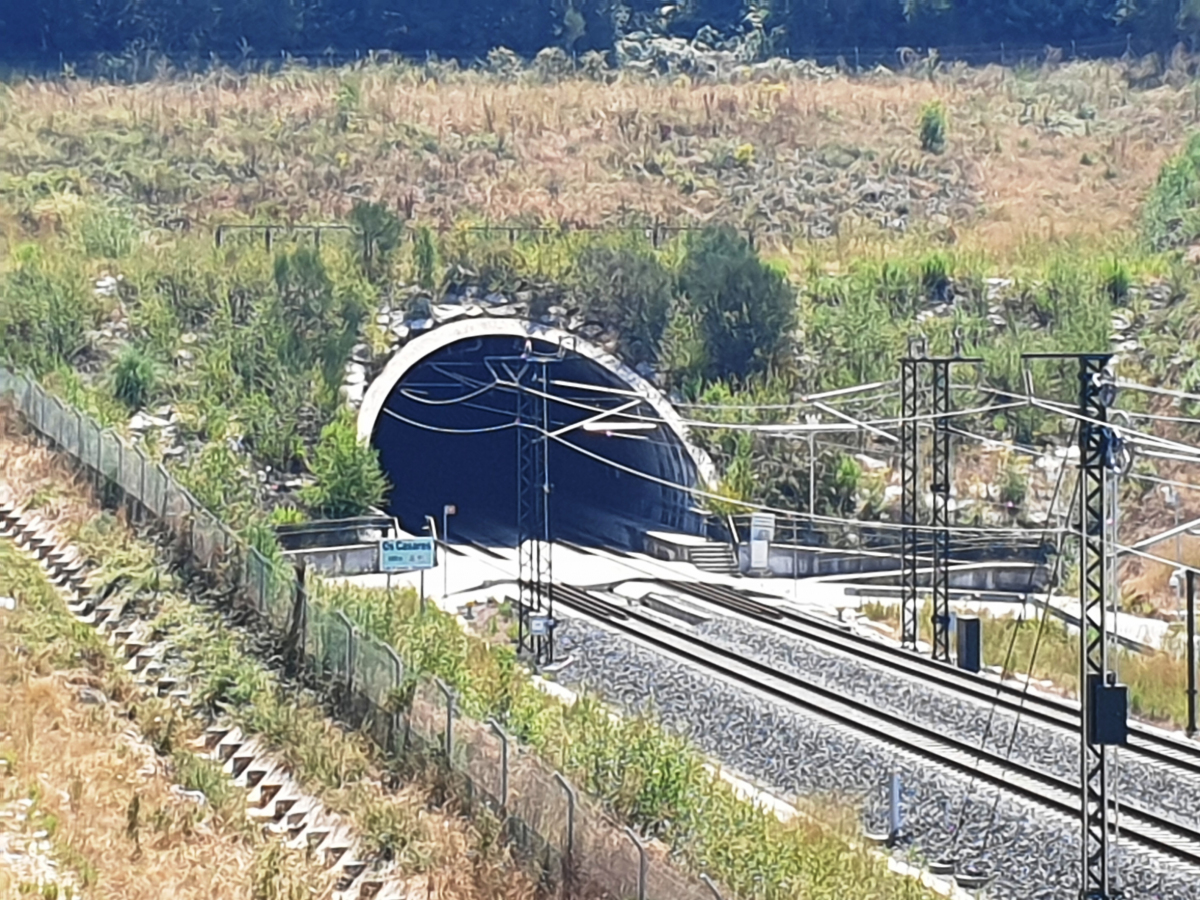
[0,498,408,900]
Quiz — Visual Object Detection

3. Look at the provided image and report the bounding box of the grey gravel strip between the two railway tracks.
[694,619,1200,827]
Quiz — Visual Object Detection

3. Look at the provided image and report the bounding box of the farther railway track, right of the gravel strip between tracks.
[658,580,1200,775]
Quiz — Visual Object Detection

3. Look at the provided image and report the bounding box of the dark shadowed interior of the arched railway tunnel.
[372,336,703,550]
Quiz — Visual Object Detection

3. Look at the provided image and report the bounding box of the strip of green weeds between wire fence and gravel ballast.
[312,582,932,900]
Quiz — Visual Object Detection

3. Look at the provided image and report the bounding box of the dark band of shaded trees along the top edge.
[7,0,1200,72]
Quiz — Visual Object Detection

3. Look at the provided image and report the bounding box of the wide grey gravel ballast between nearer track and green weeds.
[556,618,1200,900]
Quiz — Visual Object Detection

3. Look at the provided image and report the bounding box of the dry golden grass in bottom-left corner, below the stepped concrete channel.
[0,546,329,900]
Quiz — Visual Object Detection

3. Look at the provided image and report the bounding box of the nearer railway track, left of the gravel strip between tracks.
[553,583,1200,865]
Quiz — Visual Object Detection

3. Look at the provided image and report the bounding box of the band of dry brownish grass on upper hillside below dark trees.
[0,62,1196,258]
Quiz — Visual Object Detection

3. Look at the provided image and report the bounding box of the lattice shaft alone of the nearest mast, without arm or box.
[1079,354,1116,900]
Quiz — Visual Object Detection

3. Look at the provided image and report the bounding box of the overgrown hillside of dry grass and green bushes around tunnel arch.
[0,54,1200,607]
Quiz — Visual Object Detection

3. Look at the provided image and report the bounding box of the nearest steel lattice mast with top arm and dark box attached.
[1024,353,1128,900]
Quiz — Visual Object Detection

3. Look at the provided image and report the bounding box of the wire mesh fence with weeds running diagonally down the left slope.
[0,366,720,900]
